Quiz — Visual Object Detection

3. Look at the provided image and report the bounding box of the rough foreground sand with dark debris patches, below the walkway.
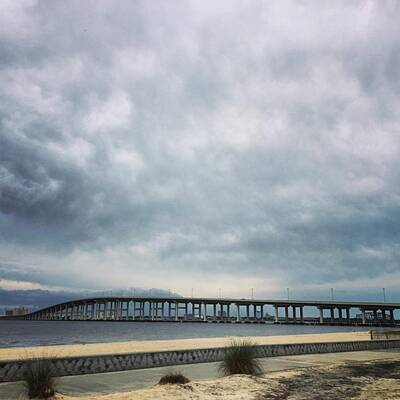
[56,360,400,400]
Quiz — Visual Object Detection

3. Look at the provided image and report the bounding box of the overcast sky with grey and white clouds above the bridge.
[0,0,400,300]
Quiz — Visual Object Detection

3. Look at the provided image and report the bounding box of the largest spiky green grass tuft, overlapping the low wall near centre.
[219,339,262,375]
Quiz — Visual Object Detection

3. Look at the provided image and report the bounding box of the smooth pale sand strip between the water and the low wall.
[0,332,370,361]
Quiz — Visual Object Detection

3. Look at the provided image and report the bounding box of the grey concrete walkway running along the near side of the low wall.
[0,349,400,400]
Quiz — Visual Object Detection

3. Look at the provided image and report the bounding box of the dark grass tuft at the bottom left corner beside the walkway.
[24,358,56,399]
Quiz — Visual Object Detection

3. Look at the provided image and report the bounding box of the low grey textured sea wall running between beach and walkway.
[0,340,400,382]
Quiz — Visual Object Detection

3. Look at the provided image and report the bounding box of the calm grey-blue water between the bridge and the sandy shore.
[0,320,367,347]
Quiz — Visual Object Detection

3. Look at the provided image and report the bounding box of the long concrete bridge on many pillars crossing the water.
[3,296,400,326]
